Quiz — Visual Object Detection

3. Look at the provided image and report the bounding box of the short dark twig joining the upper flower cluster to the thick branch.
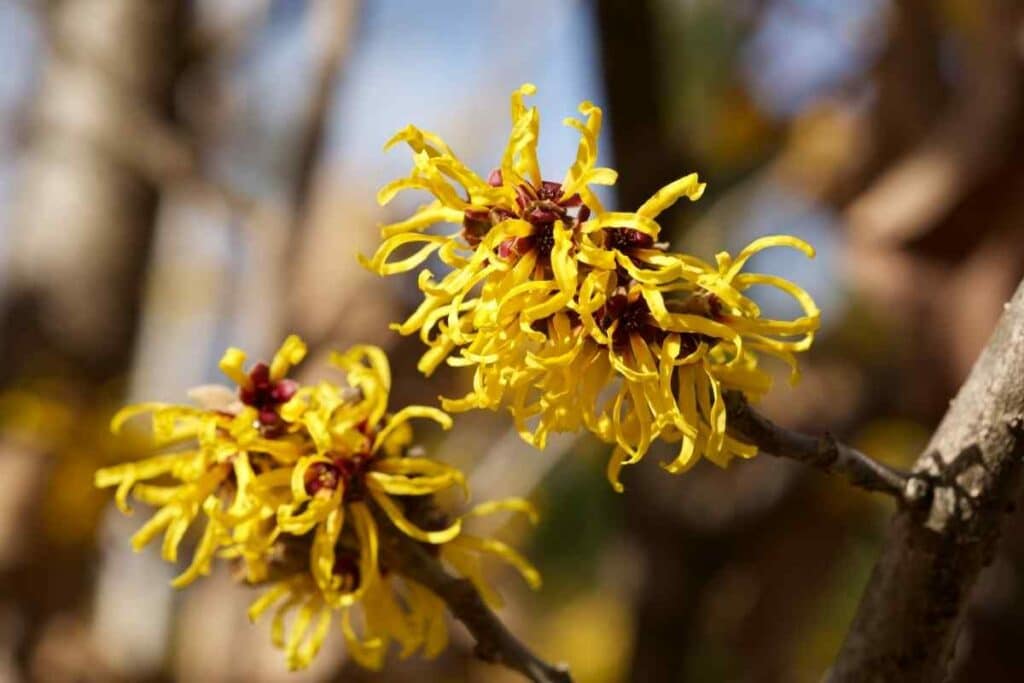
[726,391,922,502]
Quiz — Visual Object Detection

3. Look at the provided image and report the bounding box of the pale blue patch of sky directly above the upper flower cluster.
[323,0,602,193]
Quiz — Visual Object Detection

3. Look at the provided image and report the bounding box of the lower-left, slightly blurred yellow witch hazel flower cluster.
[95,336,540,669]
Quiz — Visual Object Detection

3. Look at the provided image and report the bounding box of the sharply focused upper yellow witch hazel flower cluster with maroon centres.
[362,84,819,489]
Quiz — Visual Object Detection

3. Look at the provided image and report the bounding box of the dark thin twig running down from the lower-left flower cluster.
[380,520,572,683]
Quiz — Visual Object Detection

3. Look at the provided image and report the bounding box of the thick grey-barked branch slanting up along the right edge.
[829,284,1024,683]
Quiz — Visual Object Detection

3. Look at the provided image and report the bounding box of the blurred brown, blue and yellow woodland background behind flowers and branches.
[0,0,1024,682]
